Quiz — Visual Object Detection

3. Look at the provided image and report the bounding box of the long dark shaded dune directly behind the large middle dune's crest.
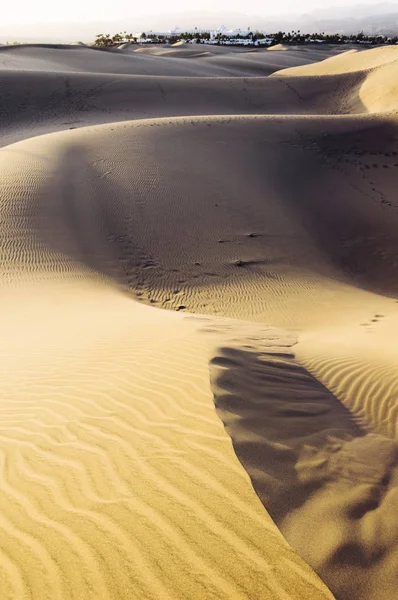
[0,67,386,146]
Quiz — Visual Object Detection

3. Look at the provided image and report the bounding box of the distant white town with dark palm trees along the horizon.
[94,26,398,47]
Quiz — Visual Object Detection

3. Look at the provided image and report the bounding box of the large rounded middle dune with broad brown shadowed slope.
[0,116,398,330]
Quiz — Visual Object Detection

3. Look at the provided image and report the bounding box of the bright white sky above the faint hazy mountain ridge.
[0,0,398,25]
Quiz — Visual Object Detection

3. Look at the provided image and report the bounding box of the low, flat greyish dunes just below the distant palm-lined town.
[0,44,344,77]
